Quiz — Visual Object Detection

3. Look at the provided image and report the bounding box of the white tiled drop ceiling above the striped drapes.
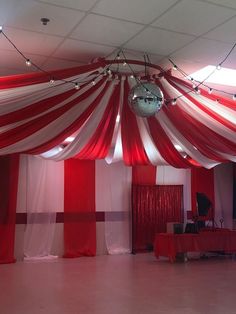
[0,0,236,74]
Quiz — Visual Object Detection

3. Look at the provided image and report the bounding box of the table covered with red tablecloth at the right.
[154,230,236,262]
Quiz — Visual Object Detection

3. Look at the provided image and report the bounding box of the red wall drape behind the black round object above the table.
[191,168,215,214]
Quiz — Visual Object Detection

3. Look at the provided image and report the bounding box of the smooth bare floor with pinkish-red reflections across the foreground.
[0,253,236,314]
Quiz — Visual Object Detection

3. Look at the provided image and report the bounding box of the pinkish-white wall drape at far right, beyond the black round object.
[214,163,233,229]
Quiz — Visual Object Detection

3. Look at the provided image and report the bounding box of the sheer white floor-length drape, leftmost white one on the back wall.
[18,155,64,260]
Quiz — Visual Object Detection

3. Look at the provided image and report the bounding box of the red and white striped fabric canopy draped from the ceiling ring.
[0,59,236,168]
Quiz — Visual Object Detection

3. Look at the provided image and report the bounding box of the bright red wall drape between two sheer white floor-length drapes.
[64,159,96,257]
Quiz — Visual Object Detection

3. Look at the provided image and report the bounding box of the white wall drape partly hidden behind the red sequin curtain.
[156,166,191,222]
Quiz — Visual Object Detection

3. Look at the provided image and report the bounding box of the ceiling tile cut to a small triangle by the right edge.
[204,17,236,45]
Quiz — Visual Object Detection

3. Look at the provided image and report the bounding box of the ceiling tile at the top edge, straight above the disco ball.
[92,0,177,24]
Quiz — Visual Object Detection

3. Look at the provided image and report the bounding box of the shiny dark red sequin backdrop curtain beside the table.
[132,185,183,252]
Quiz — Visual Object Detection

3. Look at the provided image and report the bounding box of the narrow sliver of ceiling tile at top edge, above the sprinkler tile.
[35,0,97,11]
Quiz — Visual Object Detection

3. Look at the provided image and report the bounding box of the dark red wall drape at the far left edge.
[0,155,19,264]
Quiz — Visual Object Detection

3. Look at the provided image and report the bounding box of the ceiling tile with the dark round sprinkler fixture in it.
[6,1,85,36]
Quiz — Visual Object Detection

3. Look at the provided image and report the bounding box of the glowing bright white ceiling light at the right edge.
[188,65,236,86]
